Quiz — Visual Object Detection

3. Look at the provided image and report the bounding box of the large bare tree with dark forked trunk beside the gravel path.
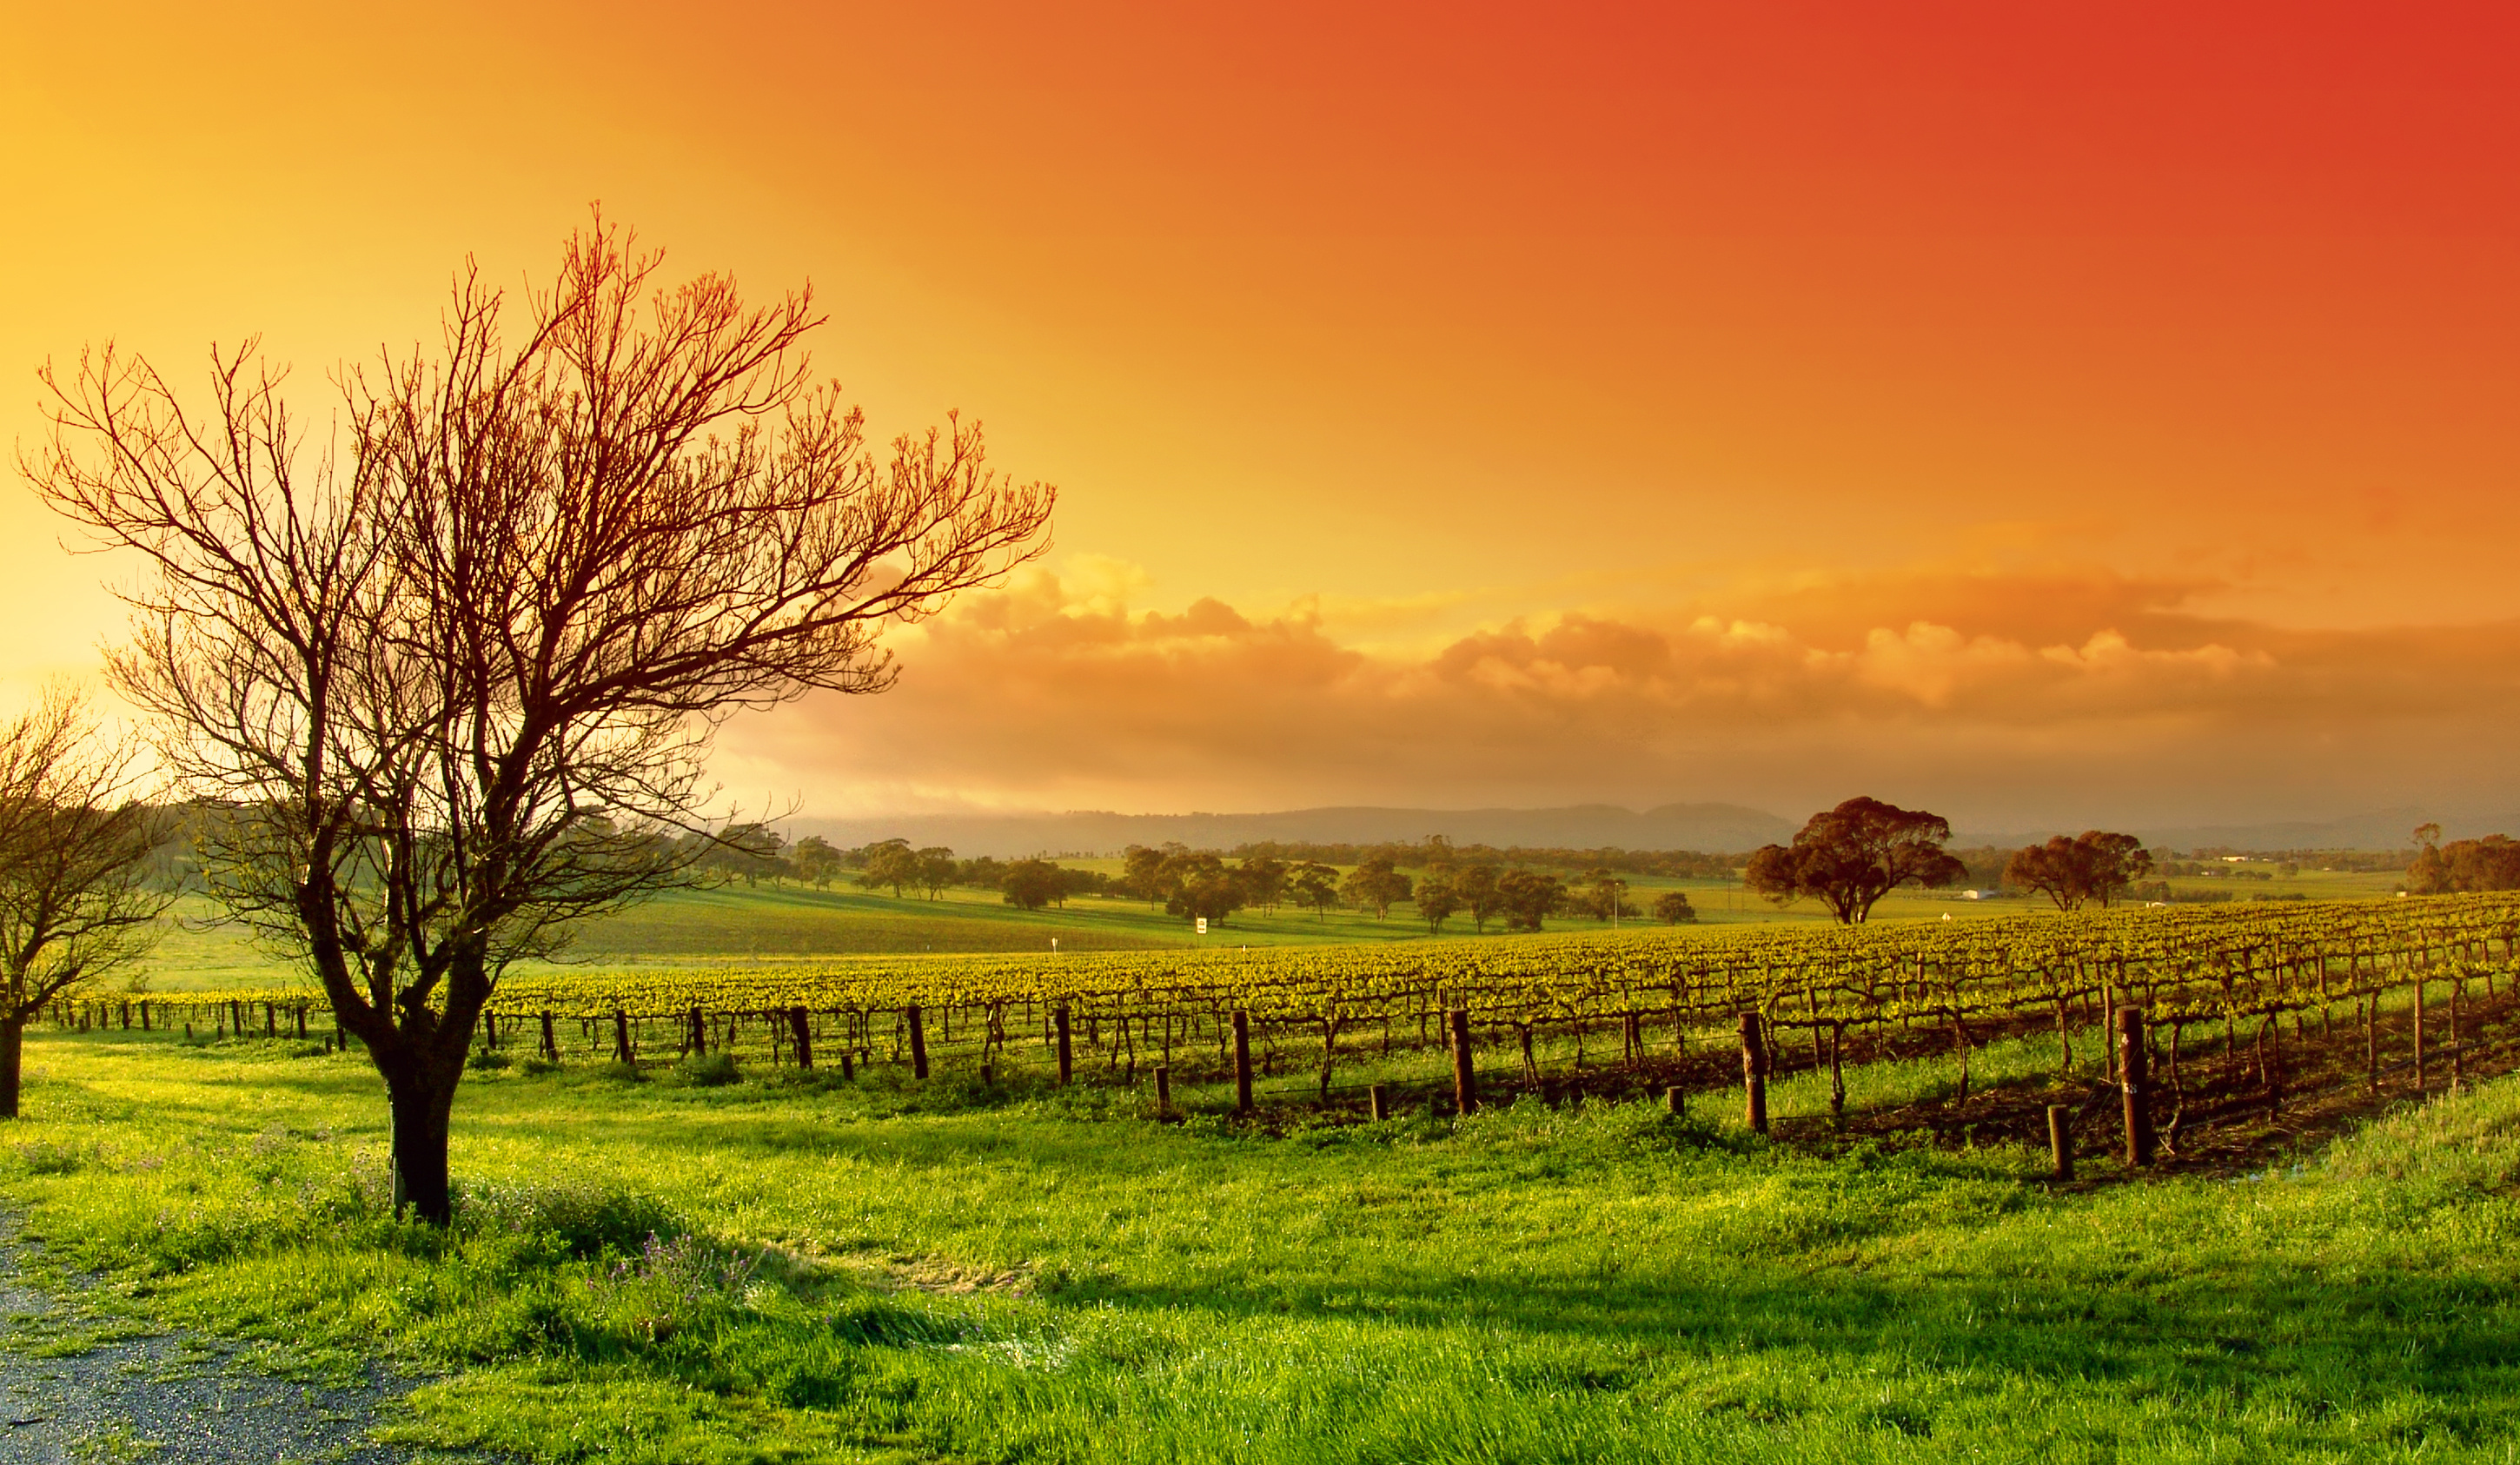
[30,219,1053,1223]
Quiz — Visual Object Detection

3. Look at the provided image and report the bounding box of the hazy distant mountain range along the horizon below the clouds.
[781,805,2520,860]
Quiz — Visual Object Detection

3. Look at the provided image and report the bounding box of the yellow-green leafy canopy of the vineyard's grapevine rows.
[61,895,2520,1069]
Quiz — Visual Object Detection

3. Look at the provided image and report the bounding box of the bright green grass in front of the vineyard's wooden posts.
[0,1034,2520,1462]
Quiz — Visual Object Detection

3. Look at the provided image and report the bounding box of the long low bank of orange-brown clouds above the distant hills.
[726,567,2520,825]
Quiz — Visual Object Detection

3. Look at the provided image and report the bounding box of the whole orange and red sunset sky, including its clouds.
[0,0,2520,830]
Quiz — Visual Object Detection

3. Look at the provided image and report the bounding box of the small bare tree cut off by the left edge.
[0,691,174,1119]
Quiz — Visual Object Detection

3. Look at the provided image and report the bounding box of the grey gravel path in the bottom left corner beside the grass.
[0,1221,468,1465]
